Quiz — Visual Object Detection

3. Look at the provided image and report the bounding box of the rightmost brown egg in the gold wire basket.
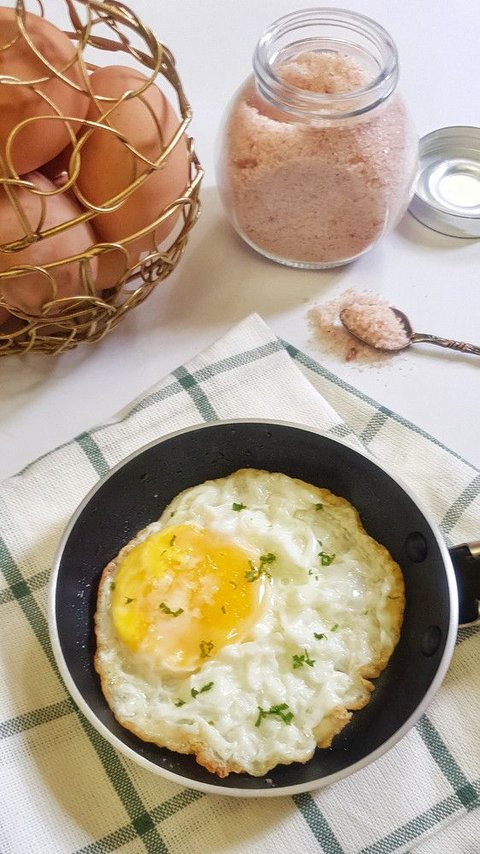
[73,66,189,288]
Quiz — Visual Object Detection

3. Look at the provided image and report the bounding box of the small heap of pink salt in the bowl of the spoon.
[341,302,410,350]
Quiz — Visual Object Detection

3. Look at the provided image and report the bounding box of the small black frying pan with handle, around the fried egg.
[50,421,480,796]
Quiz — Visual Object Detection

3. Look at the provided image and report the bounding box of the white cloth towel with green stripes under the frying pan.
[0,315,480,854]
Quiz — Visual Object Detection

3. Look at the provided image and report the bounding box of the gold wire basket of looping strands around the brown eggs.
[0,0,203,355]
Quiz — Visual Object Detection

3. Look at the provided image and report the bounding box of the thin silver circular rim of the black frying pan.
[48,418,459,798]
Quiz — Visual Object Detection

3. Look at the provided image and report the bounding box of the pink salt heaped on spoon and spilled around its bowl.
[308,288,408,366]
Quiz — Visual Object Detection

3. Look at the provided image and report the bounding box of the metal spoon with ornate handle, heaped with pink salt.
[340,302,480,356]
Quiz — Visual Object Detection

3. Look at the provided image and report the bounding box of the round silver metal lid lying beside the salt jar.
[409,126,480,237]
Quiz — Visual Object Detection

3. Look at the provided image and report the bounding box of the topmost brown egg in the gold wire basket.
[0,7,89,175]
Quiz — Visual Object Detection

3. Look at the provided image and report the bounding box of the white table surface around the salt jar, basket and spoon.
[0,0,480,478]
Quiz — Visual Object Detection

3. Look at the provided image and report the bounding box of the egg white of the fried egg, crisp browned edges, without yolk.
[95,469,405,776]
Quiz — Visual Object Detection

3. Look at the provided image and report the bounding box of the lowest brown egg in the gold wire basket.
[0,172,98,316]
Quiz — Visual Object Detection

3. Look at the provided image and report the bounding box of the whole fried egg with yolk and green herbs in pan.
[95,469,405,777]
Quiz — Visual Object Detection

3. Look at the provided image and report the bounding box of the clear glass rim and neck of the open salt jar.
[253,8,398,119]
